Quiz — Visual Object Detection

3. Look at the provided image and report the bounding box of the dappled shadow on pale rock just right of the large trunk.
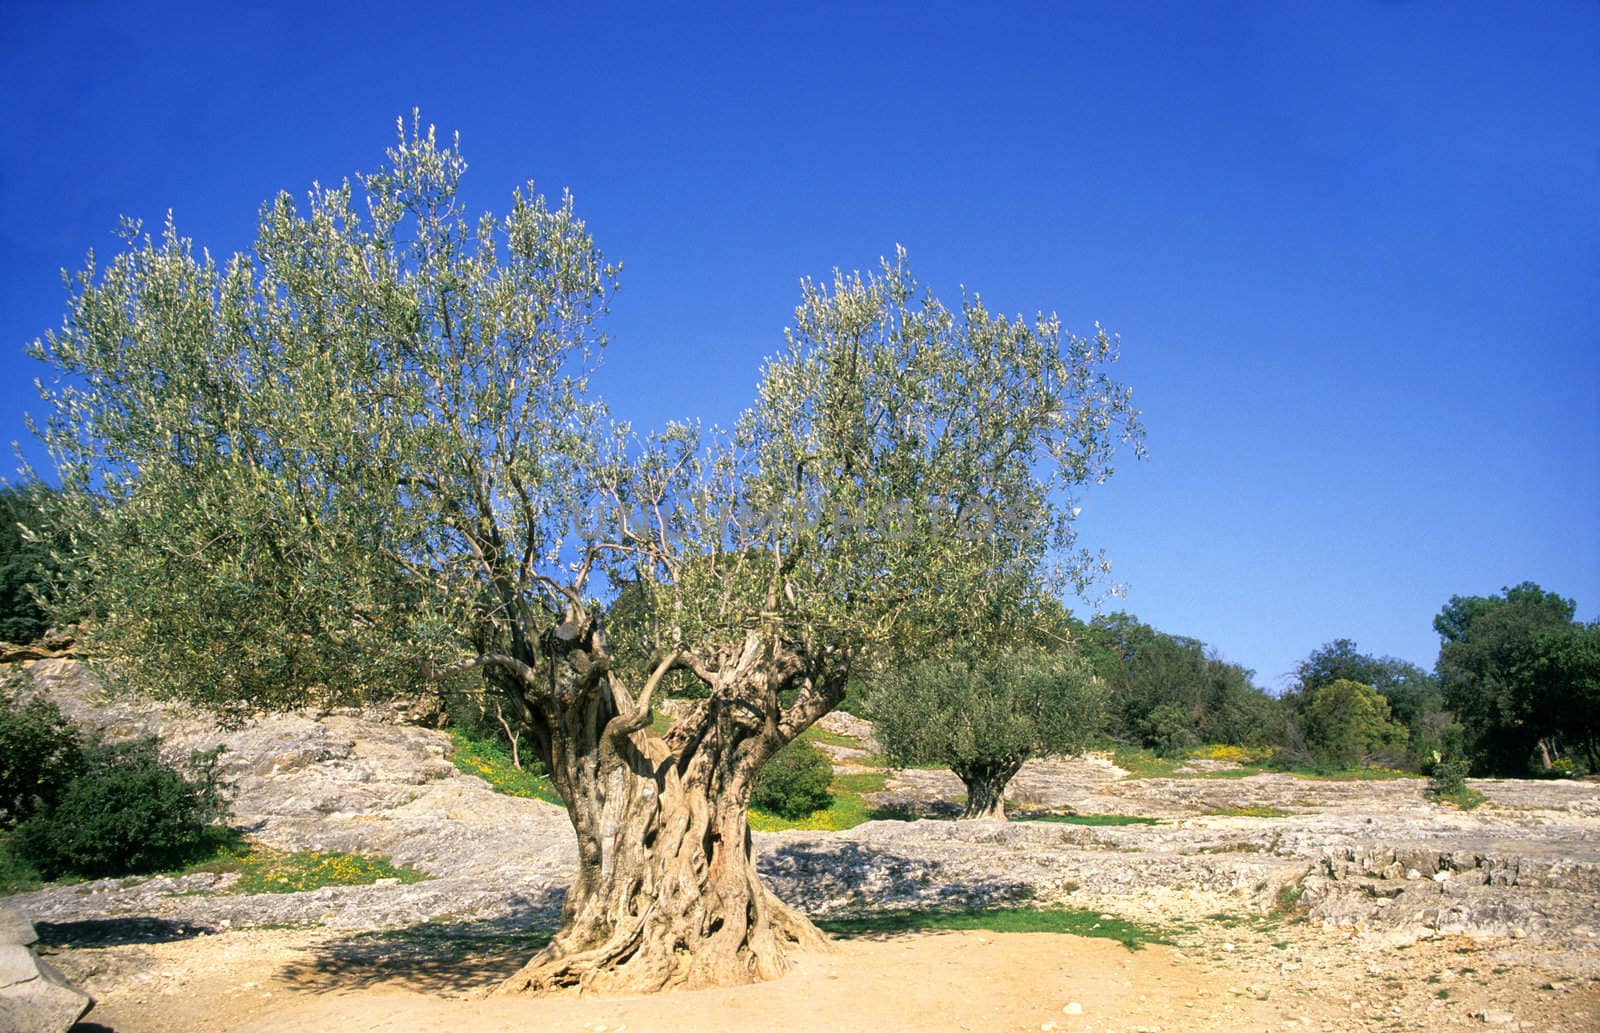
[757,840,1034,919]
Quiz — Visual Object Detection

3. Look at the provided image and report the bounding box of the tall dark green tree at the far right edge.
[1434,580,1600,776]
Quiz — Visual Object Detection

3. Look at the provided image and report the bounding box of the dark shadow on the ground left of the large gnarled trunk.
[278,889,565,996]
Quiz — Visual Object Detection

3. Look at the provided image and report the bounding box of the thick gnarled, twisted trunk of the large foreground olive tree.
[499,620,826,993]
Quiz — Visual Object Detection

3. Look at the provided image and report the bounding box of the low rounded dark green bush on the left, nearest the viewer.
[8,737,224,879]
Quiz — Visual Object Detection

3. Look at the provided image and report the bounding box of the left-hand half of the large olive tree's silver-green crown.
[34,115,616,705]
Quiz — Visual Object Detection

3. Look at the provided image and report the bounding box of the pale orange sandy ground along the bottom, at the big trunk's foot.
[54,927,1600,1033]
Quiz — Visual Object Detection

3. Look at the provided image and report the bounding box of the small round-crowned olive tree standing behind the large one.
[866,646,1104,820]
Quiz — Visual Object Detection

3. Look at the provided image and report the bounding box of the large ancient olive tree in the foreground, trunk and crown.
[37,119,1138,991]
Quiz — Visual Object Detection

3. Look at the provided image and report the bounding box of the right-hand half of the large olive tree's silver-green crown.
[630,249,1142,684]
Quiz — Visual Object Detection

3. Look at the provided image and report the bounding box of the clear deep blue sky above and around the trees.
[0,0,1600,688]
